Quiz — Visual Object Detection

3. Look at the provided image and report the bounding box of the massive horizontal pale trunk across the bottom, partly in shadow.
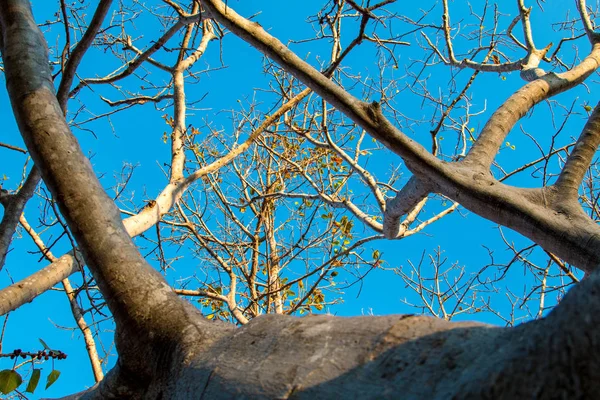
[59,272,600,400]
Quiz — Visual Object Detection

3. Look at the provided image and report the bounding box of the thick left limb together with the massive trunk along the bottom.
[0,0,600,399]
